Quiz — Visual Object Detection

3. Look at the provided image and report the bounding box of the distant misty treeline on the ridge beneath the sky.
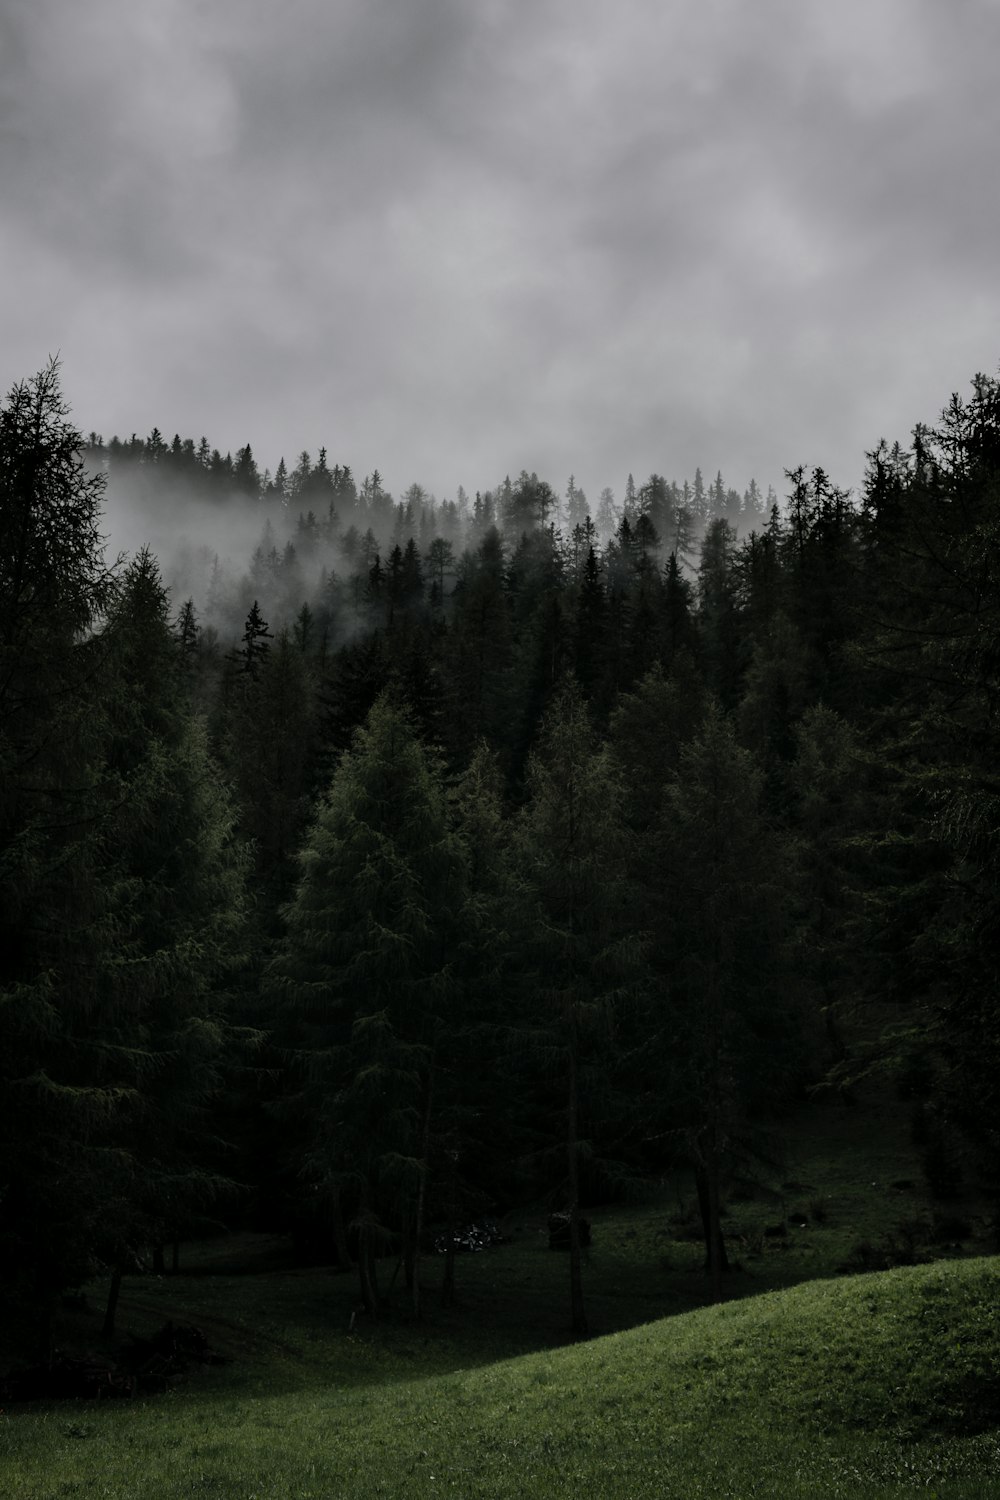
[85,428,777,648]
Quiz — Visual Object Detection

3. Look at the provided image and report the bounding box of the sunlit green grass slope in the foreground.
[0,1253,1000,1500]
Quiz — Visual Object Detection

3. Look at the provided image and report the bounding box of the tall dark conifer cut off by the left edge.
[0,363,127,1322]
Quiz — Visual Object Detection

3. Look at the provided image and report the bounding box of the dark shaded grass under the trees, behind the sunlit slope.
[19,1095,985,1400]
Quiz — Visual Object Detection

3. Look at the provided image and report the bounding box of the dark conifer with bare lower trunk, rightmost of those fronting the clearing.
[649,708,799,1296]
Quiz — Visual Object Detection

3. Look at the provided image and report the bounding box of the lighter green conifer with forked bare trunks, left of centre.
[273,696,463,1313]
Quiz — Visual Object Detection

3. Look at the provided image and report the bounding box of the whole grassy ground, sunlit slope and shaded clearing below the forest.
[0,1106,1000,1500]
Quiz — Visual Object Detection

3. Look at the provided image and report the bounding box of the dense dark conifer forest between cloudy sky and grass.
[0,365,1000,1340]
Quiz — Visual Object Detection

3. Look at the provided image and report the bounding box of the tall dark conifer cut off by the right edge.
[856,375,1000,1191]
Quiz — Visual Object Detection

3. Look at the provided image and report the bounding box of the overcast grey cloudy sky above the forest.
[0,0,1000,500]
